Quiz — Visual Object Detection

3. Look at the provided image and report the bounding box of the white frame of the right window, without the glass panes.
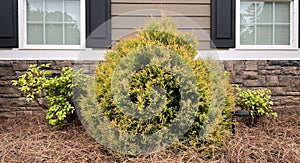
[235,0,299,49]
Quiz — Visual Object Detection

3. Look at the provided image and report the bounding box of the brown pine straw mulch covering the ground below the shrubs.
[0,109,300,162]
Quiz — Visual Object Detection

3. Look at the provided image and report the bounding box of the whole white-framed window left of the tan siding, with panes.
[21,0,85,49]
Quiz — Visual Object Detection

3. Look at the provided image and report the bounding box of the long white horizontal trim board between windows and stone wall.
[0,49,300,61]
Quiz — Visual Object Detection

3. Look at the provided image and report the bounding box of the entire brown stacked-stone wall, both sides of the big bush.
[0,60,300,119]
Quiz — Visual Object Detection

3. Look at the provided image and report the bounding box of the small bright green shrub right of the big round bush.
[236,86,277,119]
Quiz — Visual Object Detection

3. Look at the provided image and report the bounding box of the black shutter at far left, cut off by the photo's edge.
[0,0,18,48]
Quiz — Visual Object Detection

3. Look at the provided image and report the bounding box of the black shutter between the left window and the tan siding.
[86,0,111,48]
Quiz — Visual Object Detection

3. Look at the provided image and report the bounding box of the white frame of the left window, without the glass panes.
[18,0,86,49]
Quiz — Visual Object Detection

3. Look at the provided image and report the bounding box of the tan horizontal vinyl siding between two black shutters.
[112,0,210,49]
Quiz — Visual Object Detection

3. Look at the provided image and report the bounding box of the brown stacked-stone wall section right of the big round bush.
[223,60,300,109]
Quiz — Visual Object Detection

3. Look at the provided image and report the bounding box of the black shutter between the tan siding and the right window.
[211,0,236,48]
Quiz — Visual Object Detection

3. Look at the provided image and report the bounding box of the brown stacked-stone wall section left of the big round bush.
[0,60,72,119]
